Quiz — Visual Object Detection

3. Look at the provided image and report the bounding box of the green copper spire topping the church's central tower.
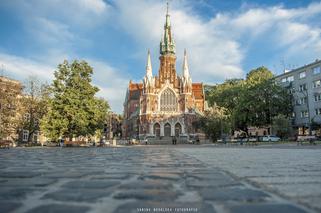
[160,2,175,55]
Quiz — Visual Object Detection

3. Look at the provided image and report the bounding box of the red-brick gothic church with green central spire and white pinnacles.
[122,7,205,138]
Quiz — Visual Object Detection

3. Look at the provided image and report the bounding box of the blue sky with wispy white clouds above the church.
[0,0,321,113]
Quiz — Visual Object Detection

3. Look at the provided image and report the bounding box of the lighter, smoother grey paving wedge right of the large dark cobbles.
[180,144,321,212]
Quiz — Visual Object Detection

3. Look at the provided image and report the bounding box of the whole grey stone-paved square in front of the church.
[0,146,321,213]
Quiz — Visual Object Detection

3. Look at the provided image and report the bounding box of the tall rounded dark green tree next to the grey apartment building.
[233,67,292,132]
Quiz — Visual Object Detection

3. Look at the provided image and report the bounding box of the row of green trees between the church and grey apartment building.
[195,67,292,140]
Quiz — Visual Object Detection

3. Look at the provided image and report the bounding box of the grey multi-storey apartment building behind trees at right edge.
[276,60,321,135]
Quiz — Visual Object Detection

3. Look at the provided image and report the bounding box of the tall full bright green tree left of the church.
[41,60,109,140]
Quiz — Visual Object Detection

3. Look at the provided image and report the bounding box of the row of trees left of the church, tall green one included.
[0,60,109,141]
